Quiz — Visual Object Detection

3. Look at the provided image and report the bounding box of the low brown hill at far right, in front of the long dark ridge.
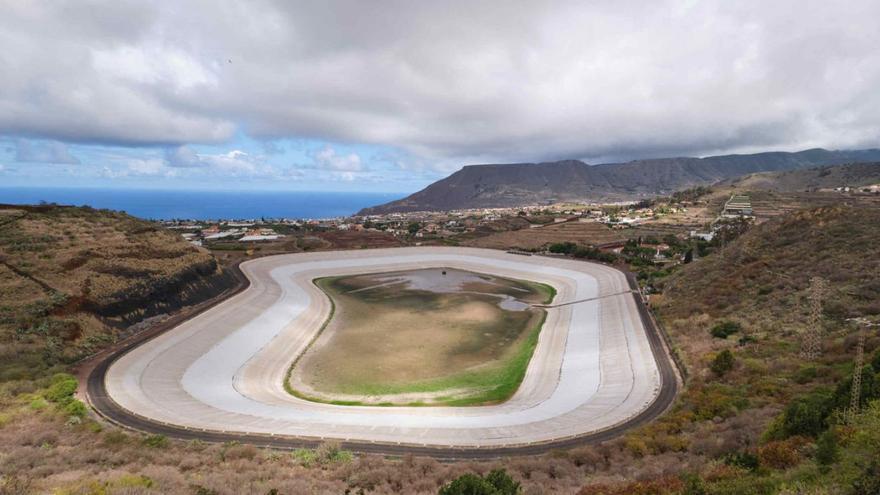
[718,162,880,192]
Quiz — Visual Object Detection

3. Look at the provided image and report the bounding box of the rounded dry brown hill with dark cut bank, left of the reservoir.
[0,206,232,363]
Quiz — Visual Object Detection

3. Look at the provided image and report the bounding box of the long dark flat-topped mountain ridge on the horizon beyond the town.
[359,149,880,215]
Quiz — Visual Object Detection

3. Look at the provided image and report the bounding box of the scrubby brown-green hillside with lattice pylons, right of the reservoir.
[616,206,880,493]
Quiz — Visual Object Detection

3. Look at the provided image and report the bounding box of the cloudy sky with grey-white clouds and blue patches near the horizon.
[0,0,880,192]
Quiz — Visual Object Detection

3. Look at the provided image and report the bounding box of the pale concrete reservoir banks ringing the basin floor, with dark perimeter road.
[88,247,676,457]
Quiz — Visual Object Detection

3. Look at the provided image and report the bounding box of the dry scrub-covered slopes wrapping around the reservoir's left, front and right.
[0,205,880,495]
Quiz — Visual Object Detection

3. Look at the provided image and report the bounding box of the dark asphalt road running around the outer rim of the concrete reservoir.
[86,250,678,459]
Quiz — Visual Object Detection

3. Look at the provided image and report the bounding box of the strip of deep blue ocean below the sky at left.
[0,187,404,220]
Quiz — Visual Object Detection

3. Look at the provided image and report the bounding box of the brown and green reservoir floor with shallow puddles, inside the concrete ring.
[291,268,551,405]
